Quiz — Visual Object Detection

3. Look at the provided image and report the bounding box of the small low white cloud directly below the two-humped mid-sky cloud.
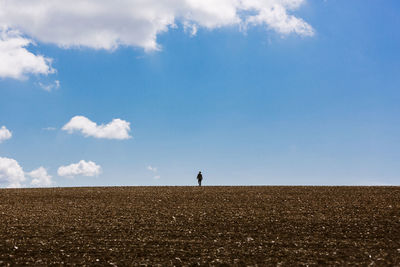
[57,160,101,177]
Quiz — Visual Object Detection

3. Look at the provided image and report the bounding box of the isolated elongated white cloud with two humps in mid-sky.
[62,116,131,140]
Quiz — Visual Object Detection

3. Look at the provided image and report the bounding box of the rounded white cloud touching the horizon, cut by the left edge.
[0,157,25,188]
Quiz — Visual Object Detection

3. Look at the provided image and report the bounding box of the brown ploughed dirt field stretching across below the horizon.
[0,187,400,266]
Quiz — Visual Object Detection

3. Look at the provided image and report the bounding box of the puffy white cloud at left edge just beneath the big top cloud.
[0,27,54,79]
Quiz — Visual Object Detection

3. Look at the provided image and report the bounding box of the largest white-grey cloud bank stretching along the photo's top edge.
[0,0,314,51]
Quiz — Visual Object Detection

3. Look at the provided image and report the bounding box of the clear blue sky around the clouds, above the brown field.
[0,0,400,187]
